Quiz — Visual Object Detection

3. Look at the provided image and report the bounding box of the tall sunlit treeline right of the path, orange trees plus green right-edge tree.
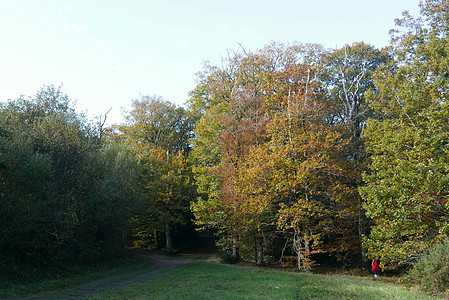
[189,1,449,270]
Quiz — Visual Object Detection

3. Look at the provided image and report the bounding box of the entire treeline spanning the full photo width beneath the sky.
[0,0,449,270]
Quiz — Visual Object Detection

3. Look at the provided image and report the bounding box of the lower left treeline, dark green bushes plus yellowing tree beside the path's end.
[0,86,196,272]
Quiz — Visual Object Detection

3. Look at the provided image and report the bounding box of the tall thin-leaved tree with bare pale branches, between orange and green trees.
[319,42,390,266]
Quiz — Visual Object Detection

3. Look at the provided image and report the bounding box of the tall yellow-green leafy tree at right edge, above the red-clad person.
[362,0,449,268]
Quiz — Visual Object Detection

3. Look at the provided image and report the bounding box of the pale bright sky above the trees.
[0,0,419,124]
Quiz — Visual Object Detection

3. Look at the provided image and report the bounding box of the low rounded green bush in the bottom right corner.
[406,240,449,293]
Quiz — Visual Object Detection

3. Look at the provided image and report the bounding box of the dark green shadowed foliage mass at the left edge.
[0,86,137,269]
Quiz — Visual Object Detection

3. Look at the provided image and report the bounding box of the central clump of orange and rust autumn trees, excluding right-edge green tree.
[190,43,386,269]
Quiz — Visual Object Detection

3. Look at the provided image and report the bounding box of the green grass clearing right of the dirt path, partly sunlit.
[92,261,435,300]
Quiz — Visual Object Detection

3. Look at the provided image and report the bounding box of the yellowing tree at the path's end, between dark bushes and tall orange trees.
[121,96,195,253]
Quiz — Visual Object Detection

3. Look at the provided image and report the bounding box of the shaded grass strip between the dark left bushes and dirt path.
[0,255,151,298]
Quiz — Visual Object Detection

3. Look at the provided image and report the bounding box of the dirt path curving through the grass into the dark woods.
[11,254,195,299]
